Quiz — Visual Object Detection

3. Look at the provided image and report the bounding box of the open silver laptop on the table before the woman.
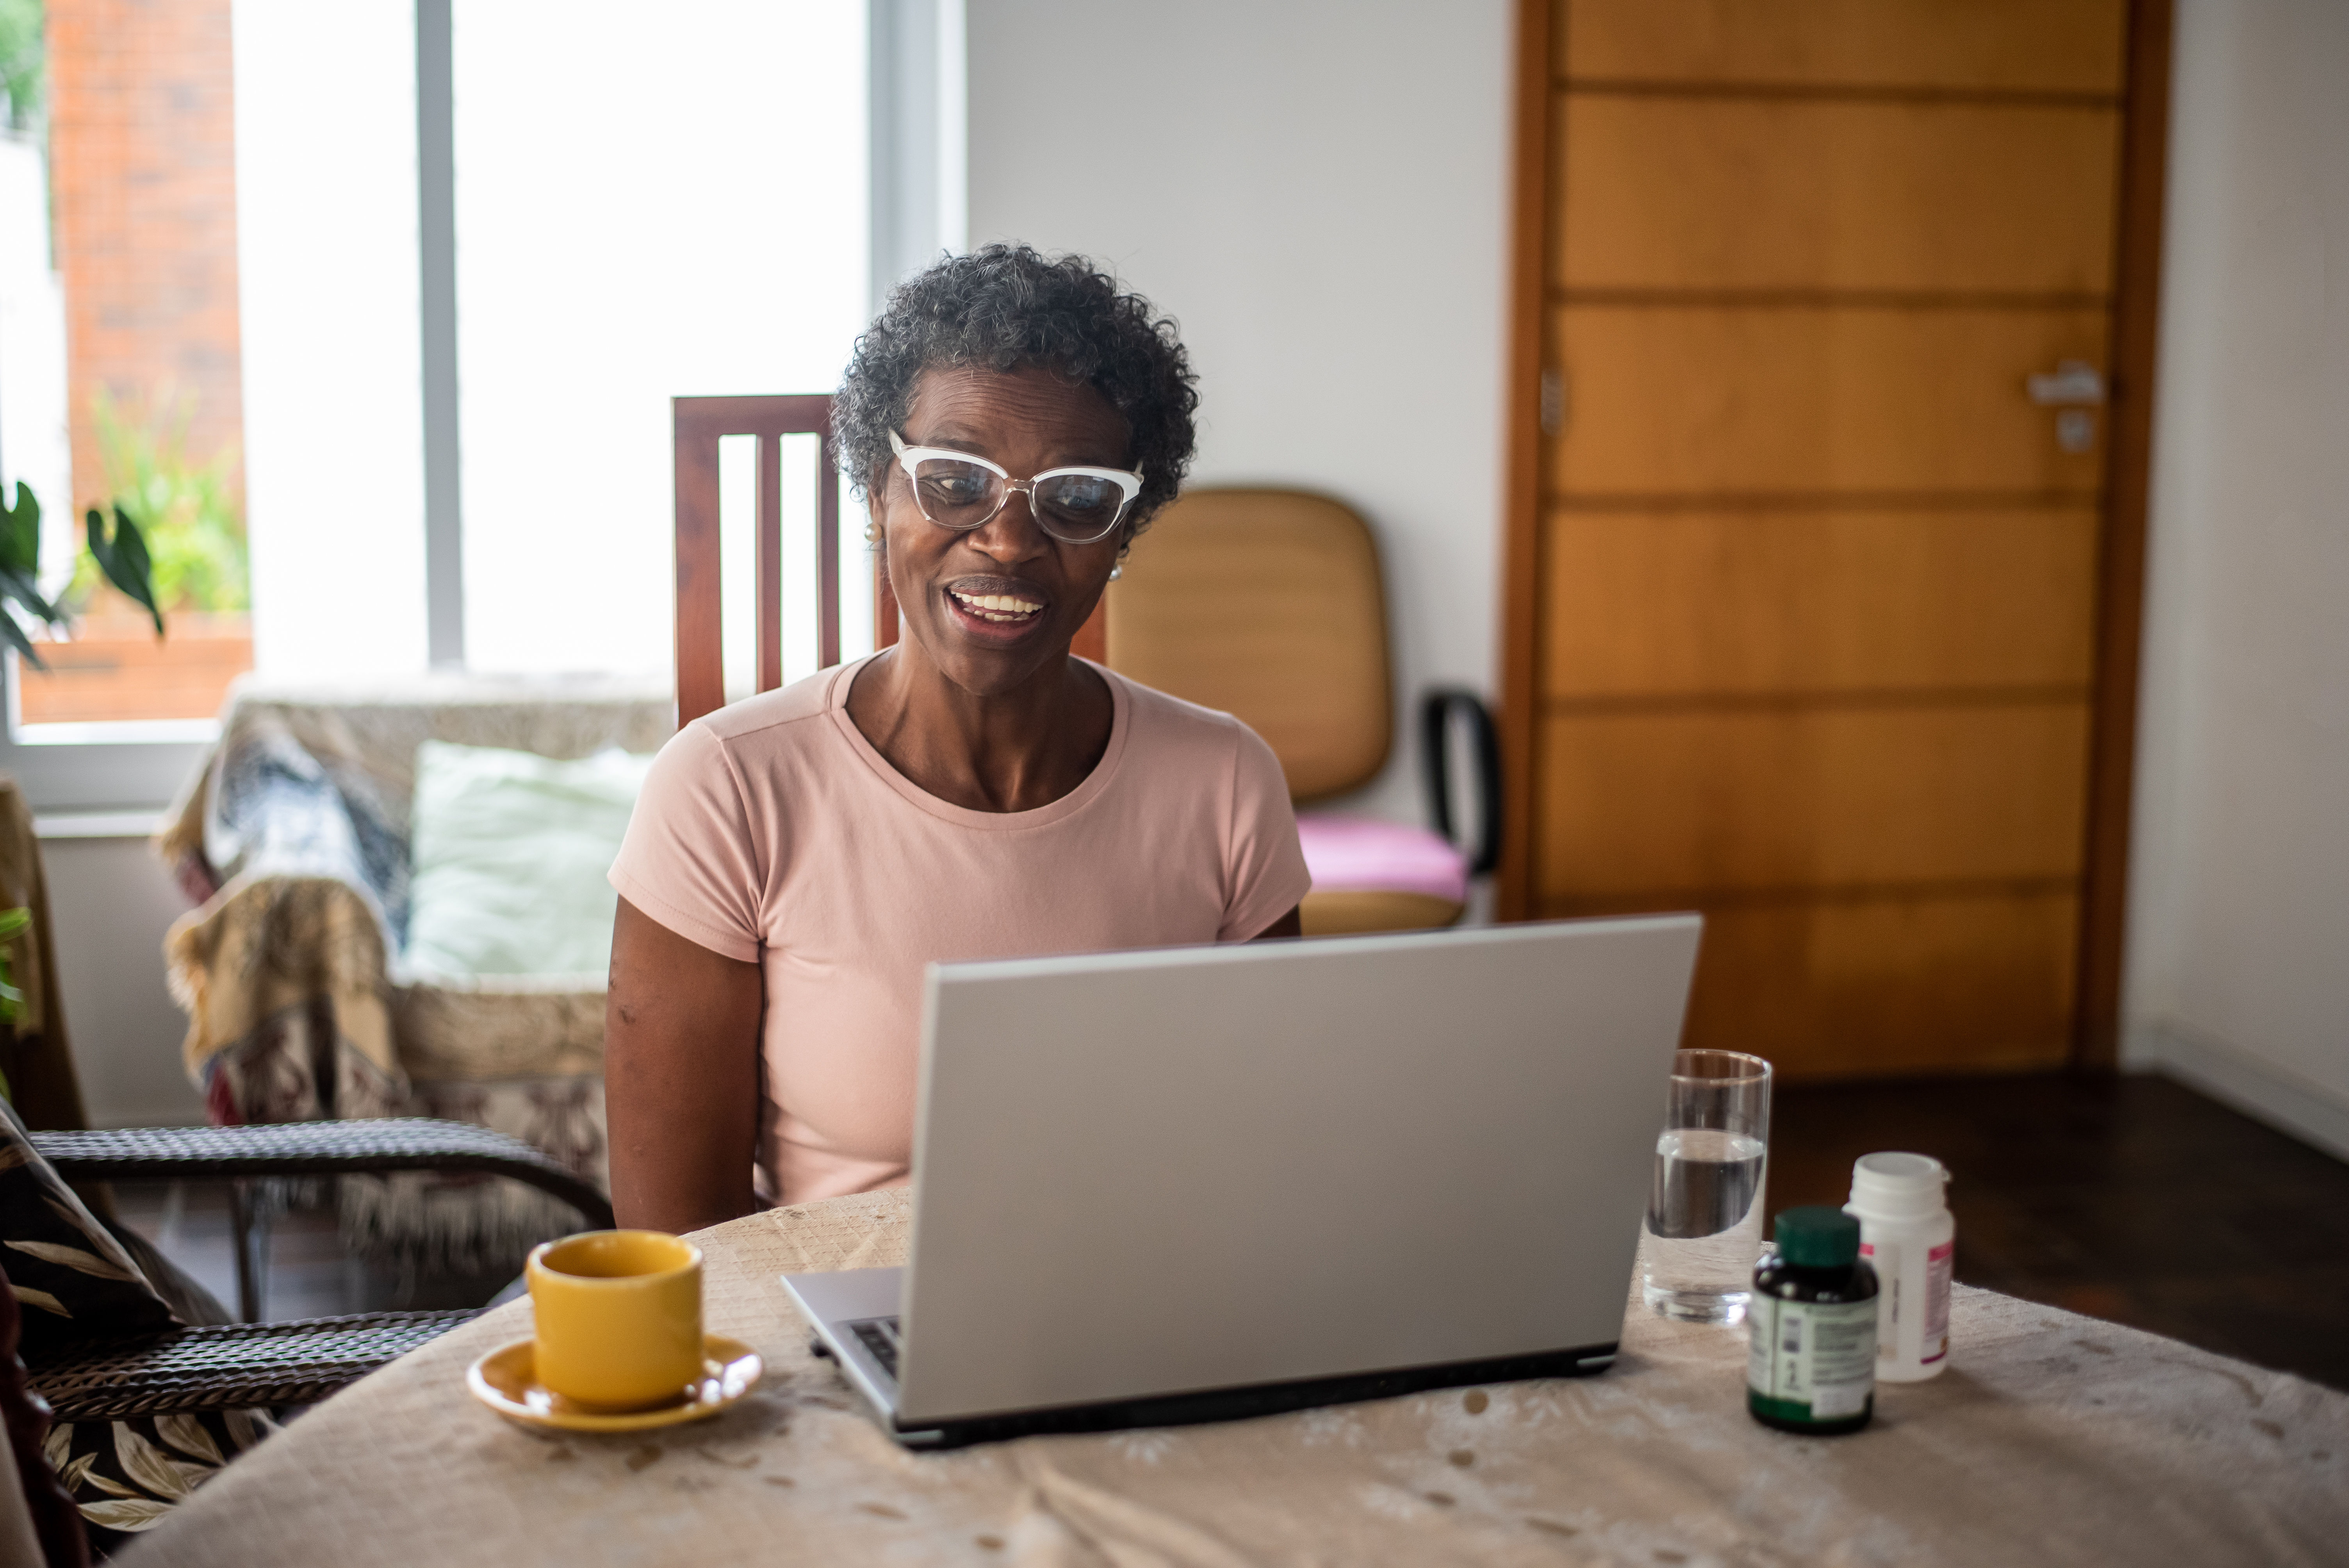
[784,916,1701,1446]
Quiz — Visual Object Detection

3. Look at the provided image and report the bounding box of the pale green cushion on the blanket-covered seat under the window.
[404,739,653,979]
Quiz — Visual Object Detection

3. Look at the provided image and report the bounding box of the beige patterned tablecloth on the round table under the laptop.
[125,1192,2349,1568]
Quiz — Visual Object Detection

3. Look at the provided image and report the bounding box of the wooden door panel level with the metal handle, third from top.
[1548,305,2107,495]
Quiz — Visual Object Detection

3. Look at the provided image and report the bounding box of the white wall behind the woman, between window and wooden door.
[968,0,1513,819]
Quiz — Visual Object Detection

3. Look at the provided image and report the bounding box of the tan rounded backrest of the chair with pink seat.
[1104,491,1395,800]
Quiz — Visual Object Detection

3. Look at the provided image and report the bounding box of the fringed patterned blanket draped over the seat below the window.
[157,678,674,1272]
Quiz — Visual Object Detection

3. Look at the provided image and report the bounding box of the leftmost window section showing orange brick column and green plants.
[0,0,251,770]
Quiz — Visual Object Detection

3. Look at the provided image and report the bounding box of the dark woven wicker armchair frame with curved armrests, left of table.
[28,1120,613,1420]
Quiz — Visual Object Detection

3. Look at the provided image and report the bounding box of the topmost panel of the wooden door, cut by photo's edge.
[1551,0,2128,94]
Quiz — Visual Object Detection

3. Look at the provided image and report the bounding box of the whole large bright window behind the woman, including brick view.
[0,0,961,810]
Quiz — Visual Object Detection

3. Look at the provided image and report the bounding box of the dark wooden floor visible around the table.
[115,1077,2349,1390]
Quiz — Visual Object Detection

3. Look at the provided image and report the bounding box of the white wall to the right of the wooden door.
[2126,0,2349,1155]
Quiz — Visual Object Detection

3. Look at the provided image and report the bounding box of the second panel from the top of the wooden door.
[1551,94,2121,296]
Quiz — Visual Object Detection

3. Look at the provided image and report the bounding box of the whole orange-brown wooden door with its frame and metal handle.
[1503,0,2166,1077]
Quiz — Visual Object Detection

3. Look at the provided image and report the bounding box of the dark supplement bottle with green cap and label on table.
[1745,1209,1877,1436]
